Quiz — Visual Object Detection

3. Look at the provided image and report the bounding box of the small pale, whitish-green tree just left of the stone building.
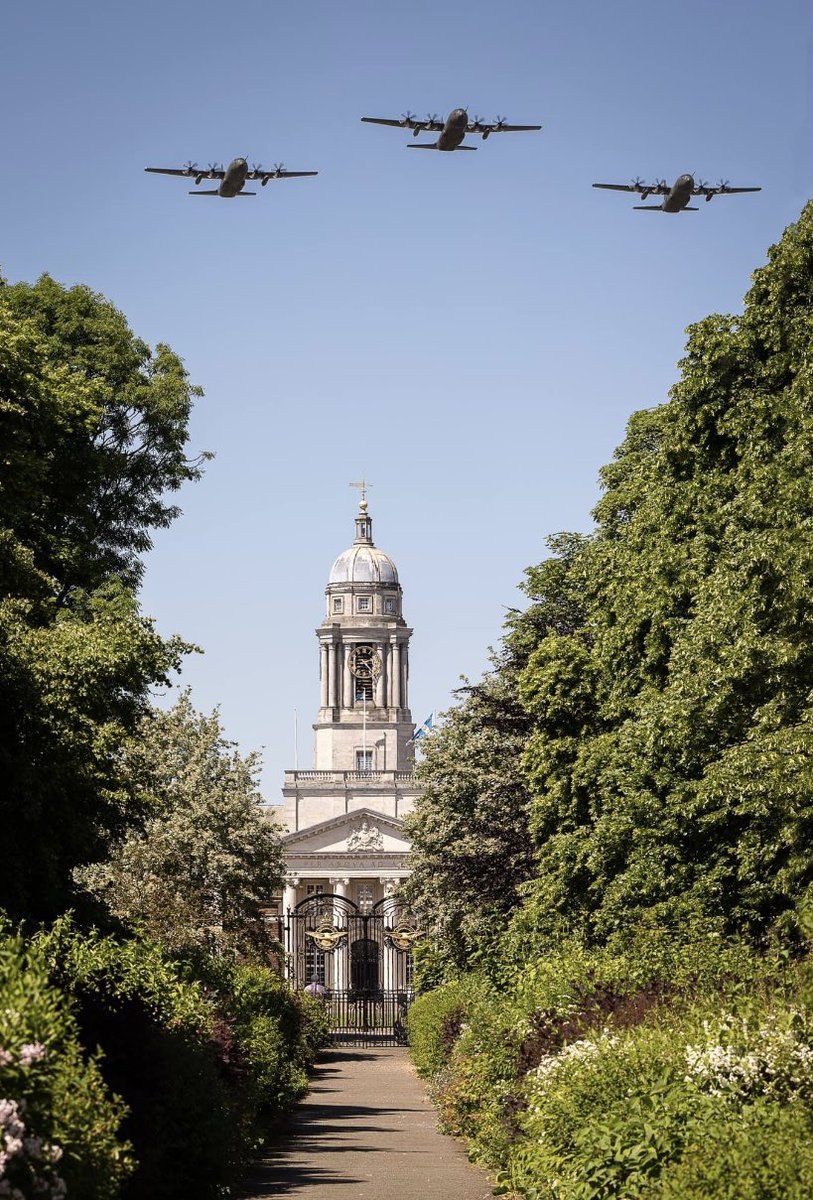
[77,692,284,955]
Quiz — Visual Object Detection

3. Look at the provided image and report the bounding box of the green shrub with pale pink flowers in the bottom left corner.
[0,929,133,1200]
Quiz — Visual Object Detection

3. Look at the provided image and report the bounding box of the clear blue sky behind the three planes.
[0,0,813,800]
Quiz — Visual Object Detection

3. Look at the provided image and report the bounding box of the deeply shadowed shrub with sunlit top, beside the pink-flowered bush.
[37,920,247,1200]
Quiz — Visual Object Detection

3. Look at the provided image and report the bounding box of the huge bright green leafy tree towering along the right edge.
[520,196,813,940]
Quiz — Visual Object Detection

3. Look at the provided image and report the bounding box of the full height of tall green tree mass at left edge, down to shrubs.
[0,276,200,917]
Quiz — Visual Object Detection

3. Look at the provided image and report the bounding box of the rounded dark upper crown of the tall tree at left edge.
[0,275,209,602]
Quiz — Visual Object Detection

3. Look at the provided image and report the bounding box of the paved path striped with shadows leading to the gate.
[247,1048,492,1200]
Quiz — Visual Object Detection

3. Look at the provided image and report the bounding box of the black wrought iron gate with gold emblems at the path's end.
[283,893,417,1046]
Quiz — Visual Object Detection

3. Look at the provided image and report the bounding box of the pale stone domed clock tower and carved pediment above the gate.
[282,492,418,912]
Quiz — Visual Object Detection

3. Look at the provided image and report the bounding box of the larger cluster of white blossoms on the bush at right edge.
[686,1010,813,1103]
